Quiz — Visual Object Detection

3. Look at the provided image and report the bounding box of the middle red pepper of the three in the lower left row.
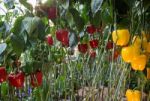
[8,72,25,88]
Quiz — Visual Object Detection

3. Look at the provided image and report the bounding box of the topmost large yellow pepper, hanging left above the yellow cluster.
[112,29,130,46]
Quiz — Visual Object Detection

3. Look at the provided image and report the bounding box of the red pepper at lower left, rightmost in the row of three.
[30,71,43,87]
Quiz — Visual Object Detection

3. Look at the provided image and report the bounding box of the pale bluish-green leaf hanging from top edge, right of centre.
[91,0,103,14]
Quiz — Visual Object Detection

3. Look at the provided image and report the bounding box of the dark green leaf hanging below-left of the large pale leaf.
[11,35,25,56]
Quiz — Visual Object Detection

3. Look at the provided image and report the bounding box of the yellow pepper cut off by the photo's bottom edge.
[126,89,141,101]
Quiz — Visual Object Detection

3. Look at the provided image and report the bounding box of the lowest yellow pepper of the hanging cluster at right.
[131,54,147,71]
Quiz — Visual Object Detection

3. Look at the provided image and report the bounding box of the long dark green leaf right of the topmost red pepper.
[70,8,85,32]
